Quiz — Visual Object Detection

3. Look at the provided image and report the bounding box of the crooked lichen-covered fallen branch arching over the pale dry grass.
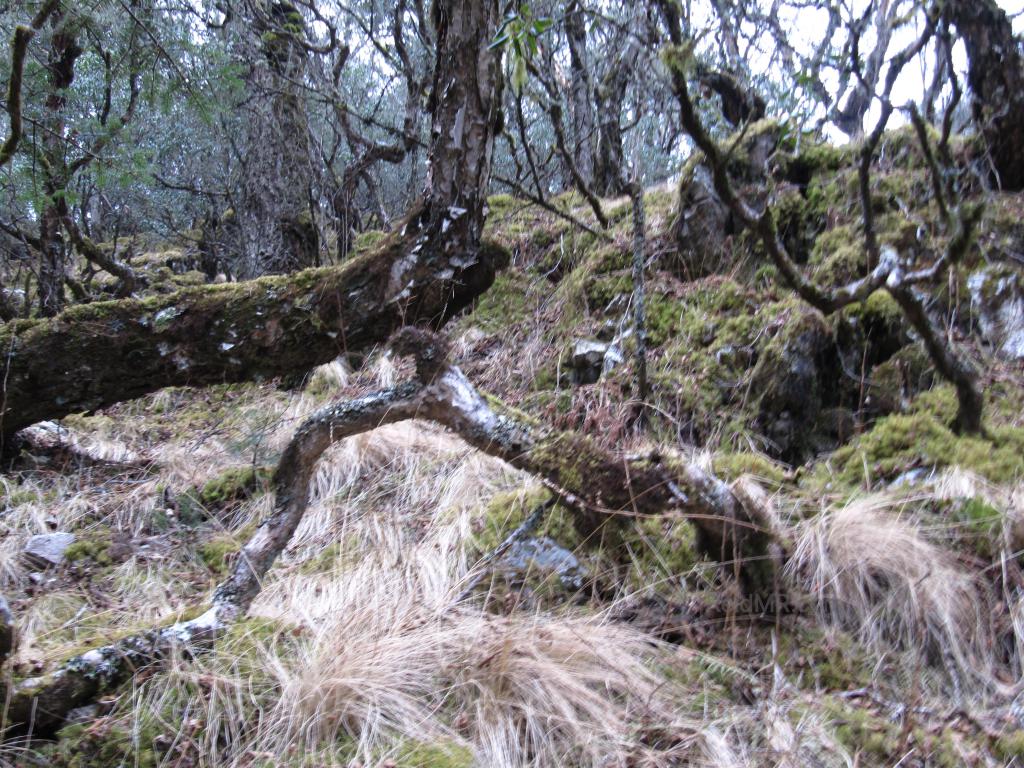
[0,329,778,733]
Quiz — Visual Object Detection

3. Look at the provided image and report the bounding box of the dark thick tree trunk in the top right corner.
[944,0,1024,191]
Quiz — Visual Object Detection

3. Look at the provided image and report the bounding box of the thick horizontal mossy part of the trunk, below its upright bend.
[0,222,508,446]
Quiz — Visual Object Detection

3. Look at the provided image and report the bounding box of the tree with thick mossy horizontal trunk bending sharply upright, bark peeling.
[0,0,508,445]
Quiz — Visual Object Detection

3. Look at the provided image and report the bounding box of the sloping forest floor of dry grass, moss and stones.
[0,131,1024,768]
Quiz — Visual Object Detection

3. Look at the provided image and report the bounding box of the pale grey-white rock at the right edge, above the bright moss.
[968,267,1024,360]
